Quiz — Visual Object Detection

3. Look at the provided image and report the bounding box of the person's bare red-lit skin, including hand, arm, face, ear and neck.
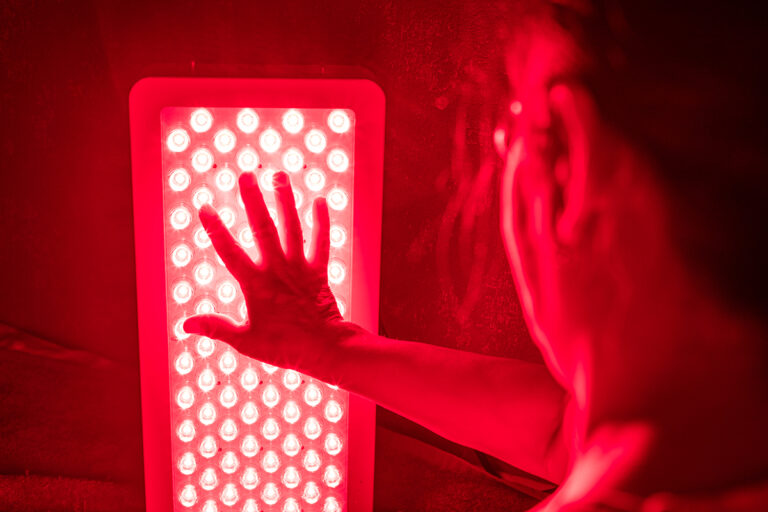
[184,19,768,510]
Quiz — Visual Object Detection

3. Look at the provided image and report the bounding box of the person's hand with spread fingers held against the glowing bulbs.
[184,172,362,373]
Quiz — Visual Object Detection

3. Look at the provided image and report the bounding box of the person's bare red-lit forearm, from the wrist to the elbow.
[313,326,566,481]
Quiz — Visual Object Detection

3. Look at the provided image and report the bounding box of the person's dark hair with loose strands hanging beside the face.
[446,0,768,318]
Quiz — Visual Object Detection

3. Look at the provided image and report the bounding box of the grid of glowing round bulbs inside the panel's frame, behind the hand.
[162,108,354,512]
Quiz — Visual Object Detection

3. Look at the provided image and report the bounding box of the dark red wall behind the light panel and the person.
[0,0,538,504]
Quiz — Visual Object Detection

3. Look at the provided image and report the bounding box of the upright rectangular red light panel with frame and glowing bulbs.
[130,78,383,512]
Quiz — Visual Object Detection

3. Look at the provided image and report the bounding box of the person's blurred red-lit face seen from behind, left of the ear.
[495,27,577,381]
